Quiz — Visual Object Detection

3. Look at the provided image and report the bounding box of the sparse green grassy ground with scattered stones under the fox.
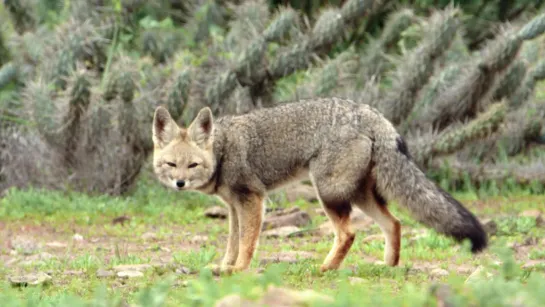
[0,174,545,306]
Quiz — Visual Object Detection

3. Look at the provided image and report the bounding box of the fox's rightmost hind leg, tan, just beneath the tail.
[354,178,401,266]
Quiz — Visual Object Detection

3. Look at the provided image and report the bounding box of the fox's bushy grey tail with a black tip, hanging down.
[373,136,488,253]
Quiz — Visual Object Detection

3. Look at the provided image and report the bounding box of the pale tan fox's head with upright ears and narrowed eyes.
[153,106,216,190]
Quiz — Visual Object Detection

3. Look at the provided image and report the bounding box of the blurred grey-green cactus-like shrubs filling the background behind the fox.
[0,0,545,195]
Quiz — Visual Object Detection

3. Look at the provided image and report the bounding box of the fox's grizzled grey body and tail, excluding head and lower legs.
[154,98,487,260]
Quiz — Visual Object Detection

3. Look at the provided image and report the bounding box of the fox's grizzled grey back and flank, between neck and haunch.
[212,98,392,188]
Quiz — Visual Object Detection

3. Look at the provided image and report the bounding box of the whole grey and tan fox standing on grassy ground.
[152,97,488,274]
